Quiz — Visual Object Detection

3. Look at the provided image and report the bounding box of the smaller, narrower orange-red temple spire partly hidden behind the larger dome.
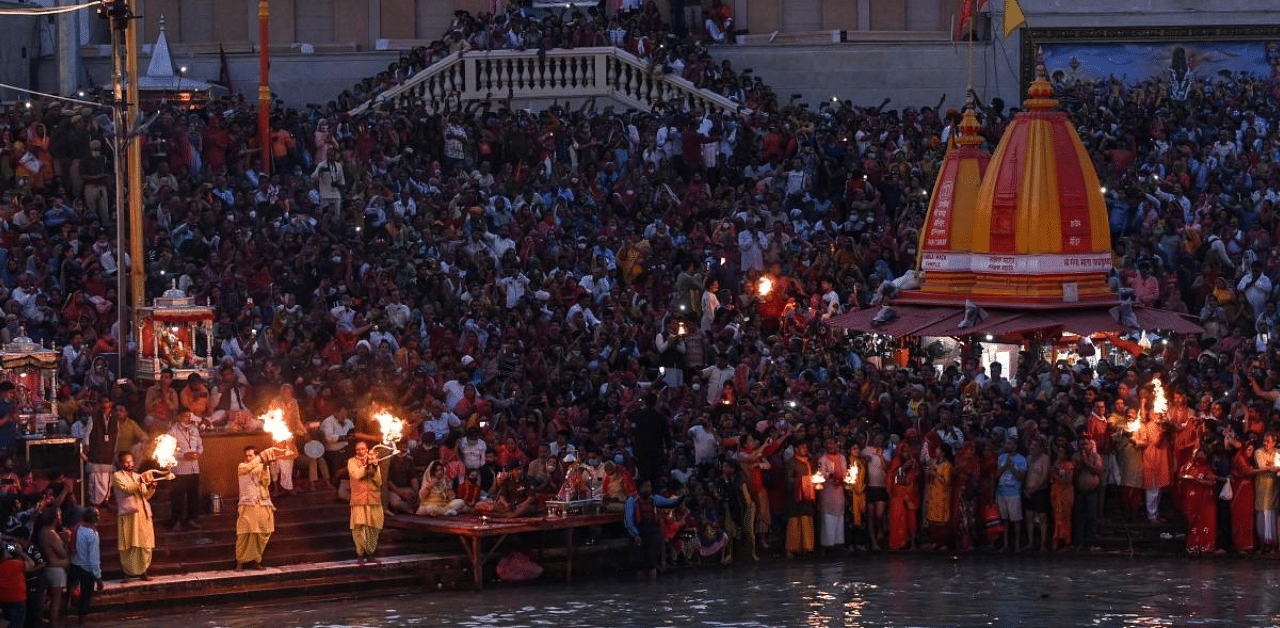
[916,101,991,295]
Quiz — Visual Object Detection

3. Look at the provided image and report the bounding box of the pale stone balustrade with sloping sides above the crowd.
[351,47,739,114]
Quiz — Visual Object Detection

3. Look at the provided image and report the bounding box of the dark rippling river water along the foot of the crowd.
[95,554,1280,628]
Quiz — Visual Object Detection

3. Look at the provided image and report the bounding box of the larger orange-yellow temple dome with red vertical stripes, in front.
[970,64,1114,307]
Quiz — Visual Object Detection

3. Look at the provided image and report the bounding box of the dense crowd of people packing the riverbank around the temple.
[0,1,1280,619]
